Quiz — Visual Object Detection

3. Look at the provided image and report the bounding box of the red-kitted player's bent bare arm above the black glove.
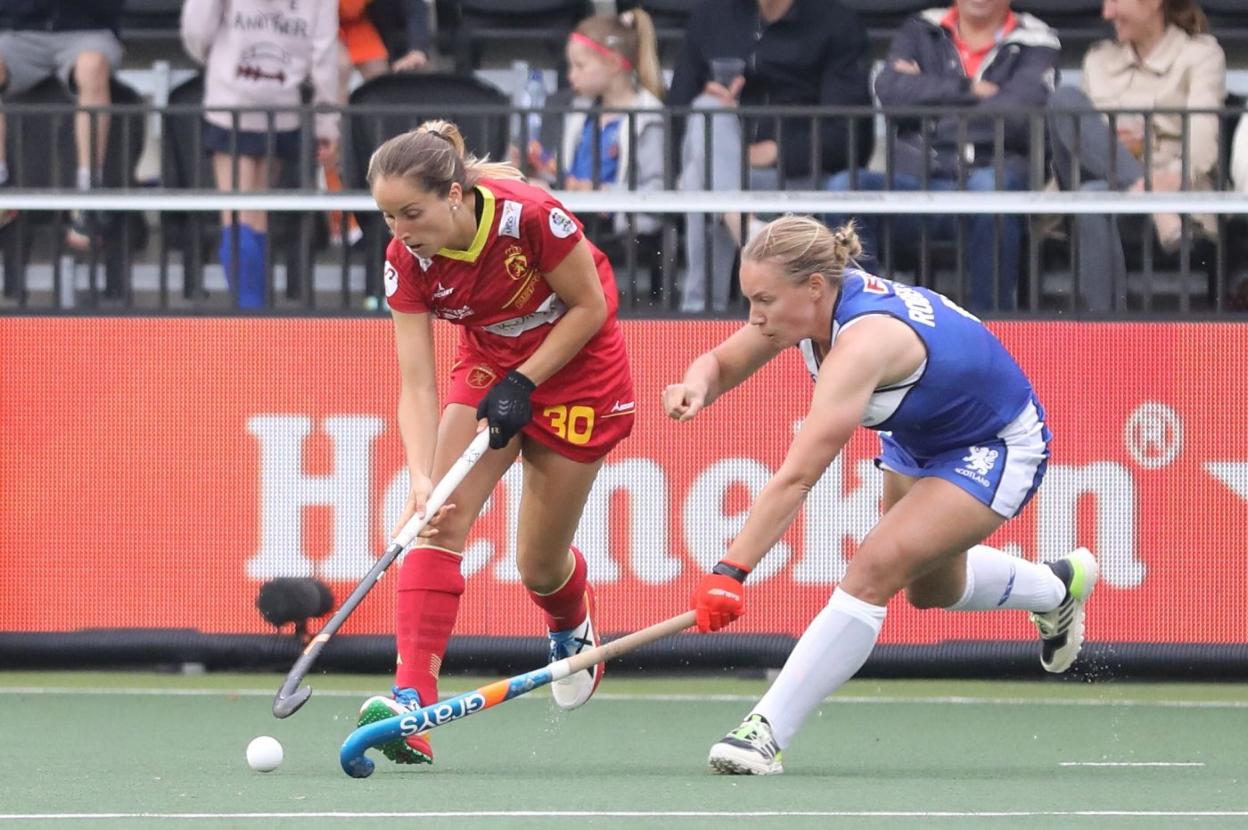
[515,240,607,384]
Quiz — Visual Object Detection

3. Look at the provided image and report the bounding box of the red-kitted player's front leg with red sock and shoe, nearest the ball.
[358,403,519,764]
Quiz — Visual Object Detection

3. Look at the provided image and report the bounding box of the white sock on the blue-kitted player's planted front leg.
[754,588,885,749]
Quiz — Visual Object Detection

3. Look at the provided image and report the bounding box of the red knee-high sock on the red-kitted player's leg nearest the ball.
[394,547,464,706]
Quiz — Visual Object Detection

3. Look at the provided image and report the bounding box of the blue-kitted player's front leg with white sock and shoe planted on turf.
[709,478,1005,775]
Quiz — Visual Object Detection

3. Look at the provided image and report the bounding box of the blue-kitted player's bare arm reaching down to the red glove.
[724,316,925,569]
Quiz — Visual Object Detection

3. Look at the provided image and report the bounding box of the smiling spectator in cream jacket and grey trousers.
[1050,0,1227,311]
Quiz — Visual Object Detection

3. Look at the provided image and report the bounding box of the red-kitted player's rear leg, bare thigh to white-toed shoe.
[517,437,602,709]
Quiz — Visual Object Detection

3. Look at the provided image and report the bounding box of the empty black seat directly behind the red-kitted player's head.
[342,74,510,295]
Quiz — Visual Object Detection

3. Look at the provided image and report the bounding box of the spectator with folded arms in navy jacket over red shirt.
[829,0,1061,312]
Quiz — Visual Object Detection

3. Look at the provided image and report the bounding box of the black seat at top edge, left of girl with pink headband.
[436,0,593,72]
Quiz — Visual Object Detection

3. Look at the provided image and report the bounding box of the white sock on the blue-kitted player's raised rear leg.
[948,544,1066,612]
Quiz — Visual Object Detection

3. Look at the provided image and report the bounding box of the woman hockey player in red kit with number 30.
[359,121,634,764]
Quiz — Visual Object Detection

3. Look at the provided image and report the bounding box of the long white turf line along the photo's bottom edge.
[0,810,1248,821]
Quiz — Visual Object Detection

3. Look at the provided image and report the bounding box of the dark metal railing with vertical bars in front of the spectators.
[0,97,1248,316]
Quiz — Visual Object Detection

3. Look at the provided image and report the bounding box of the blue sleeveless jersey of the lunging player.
[799,268,1043,458]
